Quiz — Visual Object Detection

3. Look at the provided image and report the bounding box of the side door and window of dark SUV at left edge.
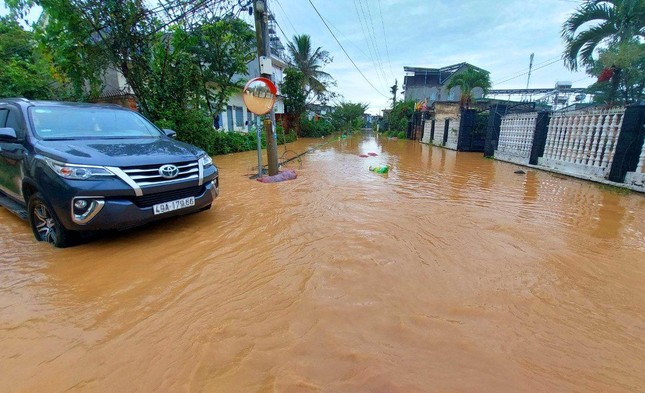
[0,105,27,202]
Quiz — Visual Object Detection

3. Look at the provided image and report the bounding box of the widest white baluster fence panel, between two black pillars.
[538,108,625,179]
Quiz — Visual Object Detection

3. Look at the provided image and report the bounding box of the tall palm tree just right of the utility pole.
[287,34,331,97]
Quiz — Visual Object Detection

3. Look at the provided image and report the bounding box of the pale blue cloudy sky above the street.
[254,0,593,114]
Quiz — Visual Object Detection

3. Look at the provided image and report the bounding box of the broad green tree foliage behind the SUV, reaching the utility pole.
[7,0,255,152]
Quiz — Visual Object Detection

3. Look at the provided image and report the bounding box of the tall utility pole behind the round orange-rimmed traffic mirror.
[253,0,278,176]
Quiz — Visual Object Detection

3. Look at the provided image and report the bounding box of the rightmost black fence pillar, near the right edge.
[609,105,645,183]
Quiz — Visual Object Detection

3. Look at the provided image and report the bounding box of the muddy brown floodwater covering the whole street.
[0,135,645,392]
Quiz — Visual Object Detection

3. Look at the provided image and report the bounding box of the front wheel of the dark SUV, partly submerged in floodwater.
[27,192,74,248]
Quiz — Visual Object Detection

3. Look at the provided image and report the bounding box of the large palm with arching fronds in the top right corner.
[562,0,645,71]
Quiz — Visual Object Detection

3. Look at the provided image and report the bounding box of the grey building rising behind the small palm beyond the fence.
[403,63,488,103]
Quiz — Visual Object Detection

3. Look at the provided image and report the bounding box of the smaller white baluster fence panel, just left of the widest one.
[495,112,538,165]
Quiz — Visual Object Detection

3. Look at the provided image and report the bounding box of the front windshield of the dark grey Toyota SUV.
[30,106,161,139]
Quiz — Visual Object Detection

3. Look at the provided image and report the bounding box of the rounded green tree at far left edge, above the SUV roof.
[0,17,55,99]
